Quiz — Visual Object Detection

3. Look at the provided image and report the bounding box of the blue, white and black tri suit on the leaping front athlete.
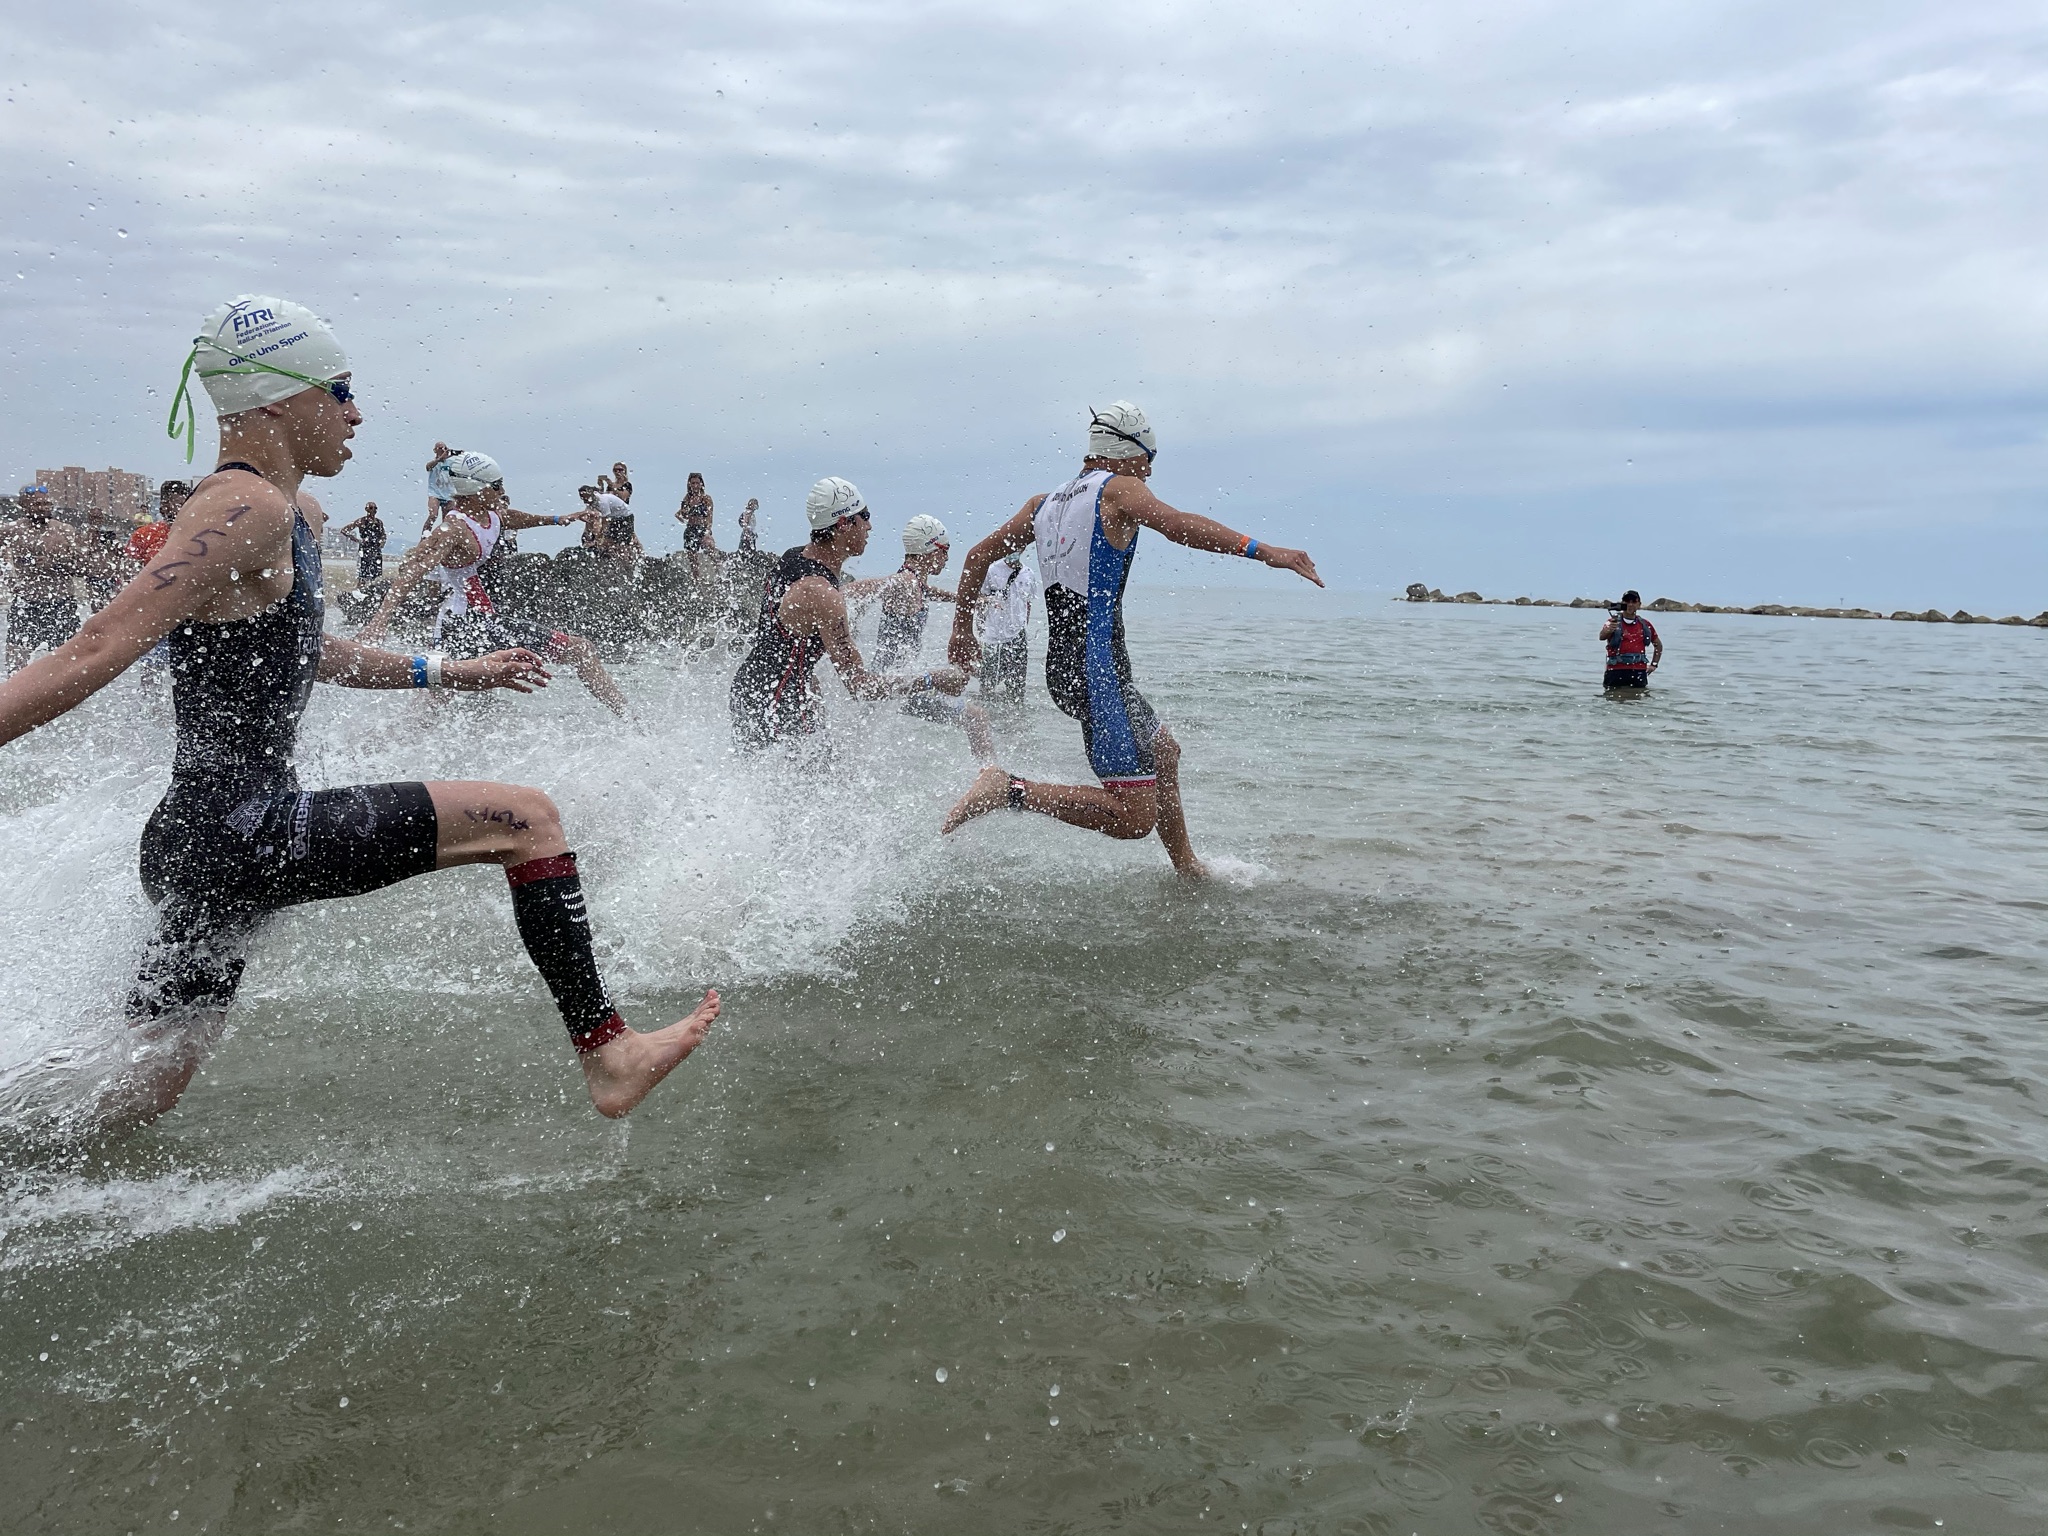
[1032,469,1159,786]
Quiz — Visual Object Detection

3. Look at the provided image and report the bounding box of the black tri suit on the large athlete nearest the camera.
[129,463,436,1024]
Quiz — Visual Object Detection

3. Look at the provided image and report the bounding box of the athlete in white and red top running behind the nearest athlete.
[360,453,627,715]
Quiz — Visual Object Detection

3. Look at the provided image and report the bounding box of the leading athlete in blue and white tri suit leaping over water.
[942,399,1323,879]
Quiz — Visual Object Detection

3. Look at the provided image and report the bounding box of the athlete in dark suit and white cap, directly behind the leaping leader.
[731,475,967,750]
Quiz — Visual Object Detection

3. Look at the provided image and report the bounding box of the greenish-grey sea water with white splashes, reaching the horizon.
[0,586,2048,1536]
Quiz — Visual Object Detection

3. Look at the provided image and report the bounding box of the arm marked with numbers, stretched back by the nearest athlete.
[0,477,291,743]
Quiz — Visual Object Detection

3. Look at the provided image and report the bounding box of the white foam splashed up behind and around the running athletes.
[0,651,1163,1133]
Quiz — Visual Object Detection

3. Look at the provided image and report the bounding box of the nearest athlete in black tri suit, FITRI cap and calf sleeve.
[0,297,719,1126]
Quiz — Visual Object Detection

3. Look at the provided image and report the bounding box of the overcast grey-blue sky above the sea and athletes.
[0,0,2048,614]
